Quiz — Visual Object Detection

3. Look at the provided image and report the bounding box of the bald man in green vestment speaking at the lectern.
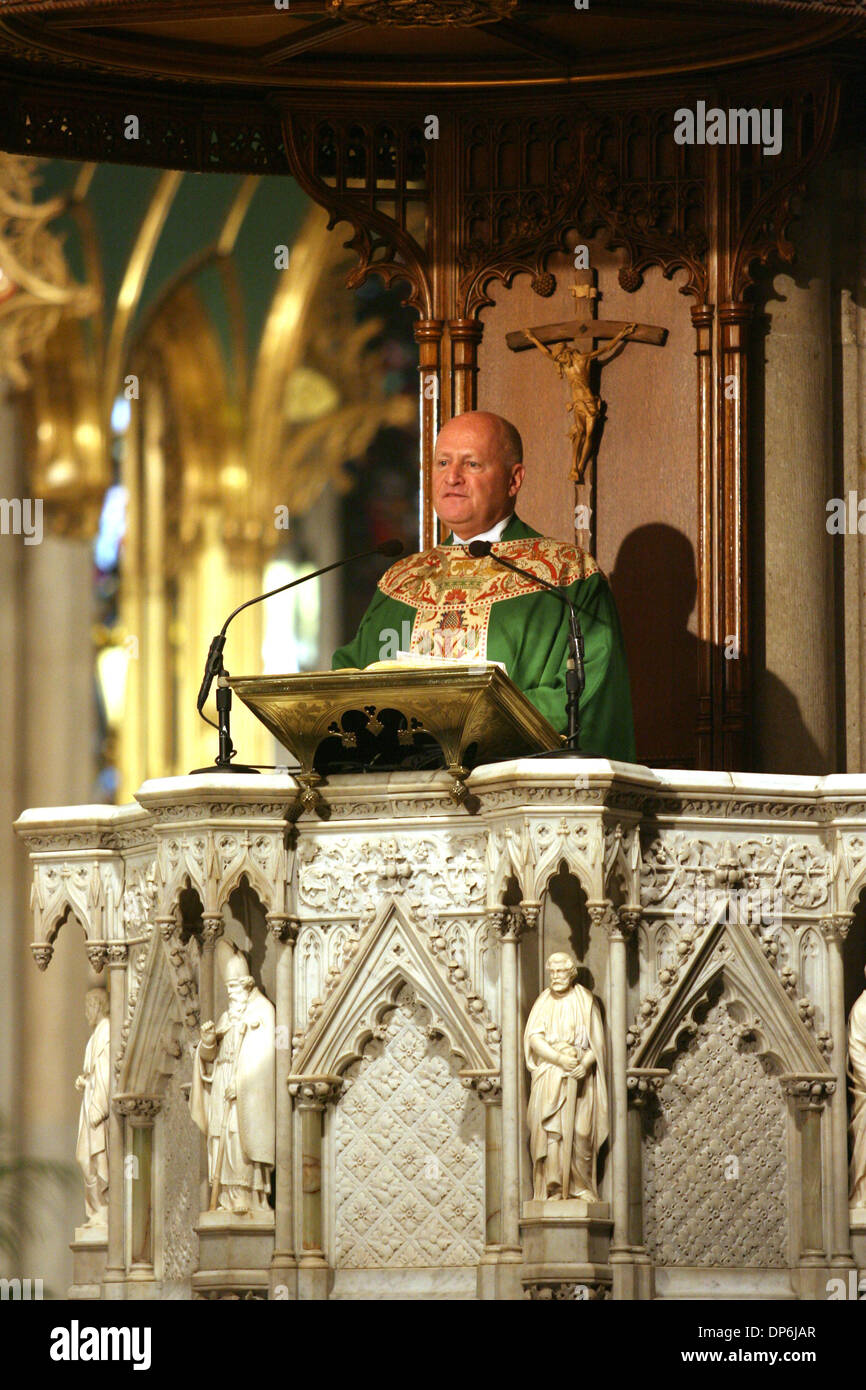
[332,410,635,762]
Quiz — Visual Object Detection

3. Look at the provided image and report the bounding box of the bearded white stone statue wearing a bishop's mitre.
[189,941,277,1215]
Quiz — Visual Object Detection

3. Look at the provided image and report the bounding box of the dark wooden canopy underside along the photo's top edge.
[0,0,866,96]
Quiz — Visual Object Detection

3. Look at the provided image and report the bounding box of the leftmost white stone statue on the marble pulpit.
[75,990,111,1227]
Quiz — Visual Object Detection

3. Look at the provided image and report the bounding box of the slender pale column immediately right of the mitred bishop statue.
[267,912,299,1298]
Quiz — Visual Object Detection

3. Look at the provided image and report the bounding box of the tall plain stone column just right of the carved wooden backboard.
[756,165,839,776]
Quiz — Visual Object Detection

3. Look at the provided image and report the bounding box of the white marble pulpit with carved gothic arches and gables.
[17,758,866,1301]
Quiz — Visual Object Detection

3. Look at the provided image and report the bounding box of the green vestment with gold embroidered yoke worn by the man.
[331,516,635,762]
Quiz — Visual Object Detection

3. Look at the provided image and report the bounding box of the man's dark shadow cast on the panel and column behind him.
[610,523,833,776]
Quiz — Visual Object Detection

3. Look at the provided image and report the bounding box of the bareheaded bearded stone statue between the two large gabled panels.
[524,952,607,1201]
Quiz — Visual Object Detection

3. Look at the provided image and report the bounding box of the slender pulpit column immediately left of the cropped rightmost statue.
[822,912,853,1269]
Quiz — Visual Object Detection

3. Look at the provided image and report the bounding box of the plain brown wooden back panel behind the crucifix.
[478,251,698,767]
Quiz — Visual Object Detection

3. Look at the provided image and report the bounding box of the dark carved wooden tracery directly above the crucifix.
[457,103,708,317]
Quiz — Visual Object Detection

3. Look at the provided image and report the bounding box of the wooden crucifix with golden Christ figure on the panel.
[505,270,667,552]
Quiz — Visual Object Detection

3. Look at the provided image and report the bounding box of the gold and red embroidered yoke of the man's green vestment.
[379,537,599,662]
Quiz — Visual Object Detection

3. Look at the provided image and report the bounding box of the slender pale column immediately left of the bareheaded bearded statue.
[492,904,538,1298]
